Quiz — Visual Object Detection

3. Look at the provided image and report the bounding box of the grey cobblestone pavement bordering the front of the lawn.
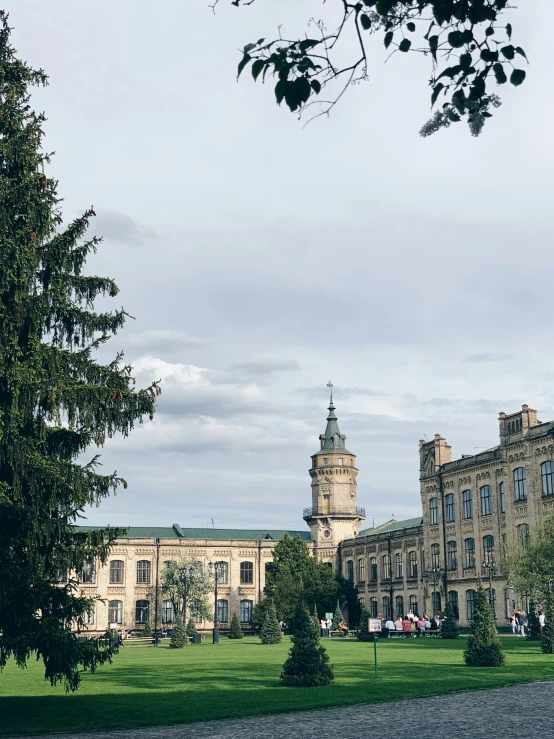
[8,682,554,739]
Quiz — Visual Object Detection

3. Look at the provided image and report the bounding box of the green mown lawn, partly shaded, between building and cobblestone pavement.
[0,638,554,734]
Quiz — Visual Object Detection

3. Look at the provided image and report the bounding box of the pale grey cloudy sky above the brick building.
[9,0,554,529]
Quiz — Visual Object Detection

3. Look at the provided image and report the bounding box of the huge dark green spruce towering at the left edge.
[0,11,159,690]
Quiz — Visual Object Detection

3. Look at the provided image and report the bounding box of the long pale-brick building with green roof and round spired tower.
[81,396,554,631]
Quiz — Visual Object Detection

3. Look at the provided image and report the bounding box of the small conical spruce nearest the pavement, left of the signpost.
[281,606,335,688]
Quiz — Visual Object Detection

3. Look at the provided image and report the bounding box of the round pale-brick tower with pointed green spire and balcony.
[304,383,365,568]
